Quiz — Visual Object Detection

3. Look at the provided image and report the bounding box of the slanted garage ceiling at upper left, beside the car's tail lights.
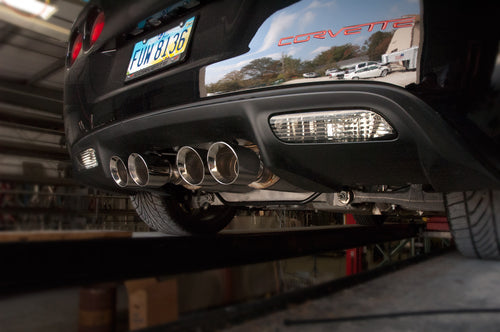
[0,0,85,114]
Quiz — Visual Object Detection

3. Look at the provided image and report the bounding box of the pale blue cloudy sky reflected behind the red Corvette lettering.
[206,0,420,83]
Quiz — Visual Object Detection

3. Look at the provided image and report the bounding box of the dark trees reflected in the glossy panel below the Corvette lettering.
[207,38,392,93]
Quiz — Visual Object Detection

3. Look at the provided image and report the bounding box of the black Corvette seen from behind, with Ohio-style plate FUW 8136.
[64,0,500,258]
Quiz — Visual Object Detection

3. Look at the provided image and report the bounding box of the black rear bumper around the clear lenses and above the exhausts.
[66,83,500,192]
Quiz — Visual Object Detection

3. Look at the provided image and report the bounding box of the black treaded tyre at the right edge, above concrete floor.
[446,190,500,259]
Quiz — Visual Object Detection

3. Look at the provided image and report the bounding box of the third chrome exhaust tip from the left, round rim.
[176,146,205,186]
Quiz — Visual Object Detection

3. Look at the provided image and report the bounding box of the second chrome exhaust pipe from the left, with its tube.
[128,153,176,188]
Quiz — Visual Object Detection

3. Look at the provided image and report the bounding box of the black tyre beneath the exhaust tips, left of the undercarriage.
[130,191,236,235]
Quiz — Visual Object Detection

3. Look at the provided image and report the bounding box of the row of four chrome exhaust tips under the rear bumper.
[109,142,268,188]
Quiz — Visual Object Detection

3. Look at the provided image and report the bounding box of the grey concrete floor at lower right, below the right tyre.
[224,253,500,332]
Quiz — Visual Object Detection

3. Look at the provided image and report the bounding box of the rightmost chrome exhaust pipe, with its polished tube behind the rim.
[207,142,263,185]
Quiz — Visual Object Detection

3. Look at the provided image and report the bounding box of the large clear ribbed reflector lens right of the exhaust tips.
[269,110,396,143]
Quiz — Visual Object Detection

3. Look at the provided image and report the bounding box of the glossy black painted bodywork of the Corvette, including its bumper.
[65,0,500,191]
